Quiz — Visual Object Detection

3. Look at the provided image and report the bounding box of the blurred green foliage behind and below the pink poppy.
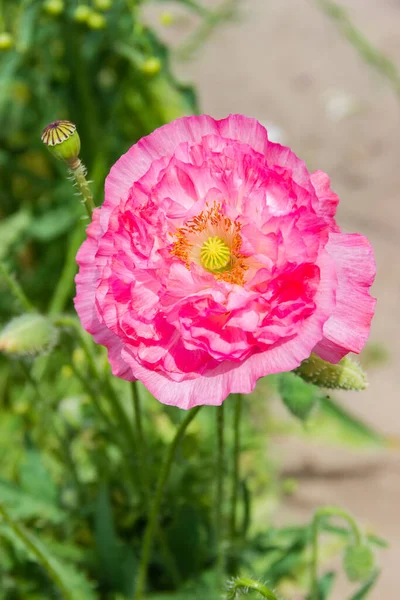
[0,0,385,600]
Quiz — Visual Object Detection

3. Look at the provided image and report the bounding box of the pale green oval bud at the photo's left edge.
[0,313,58,356]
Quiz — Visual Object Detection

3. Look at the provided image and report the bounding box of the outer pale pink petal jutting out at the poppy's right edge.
[314,233,376,363]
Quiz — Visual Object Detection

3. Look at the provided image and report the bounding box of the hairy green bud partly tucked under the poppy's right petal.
[294,354,368,391]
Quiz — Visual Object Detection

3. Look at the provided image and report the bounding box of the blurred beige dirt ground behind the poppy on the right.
[145,0,400,600]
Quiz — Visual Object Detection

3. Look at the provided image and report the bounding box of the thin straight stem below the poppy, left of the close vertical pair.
[215,404,225,589]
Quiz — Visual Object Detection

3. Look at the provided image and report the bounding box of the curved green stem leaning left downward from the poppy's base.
[134,406,201,600]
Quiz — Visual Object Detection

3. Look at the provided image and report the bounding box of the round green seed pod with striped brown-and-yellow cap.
[41,121,81,166]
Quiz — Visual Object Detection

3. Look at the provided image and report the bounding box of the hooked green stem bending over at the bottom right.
[310,506,363,600]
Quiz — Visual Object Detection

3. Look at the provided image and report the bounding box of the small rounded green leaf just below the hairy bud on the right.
[278,373,321,421]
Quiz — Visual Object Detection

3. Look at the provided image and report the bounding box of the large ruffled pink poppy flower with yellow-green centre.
[75,115,375,409]
